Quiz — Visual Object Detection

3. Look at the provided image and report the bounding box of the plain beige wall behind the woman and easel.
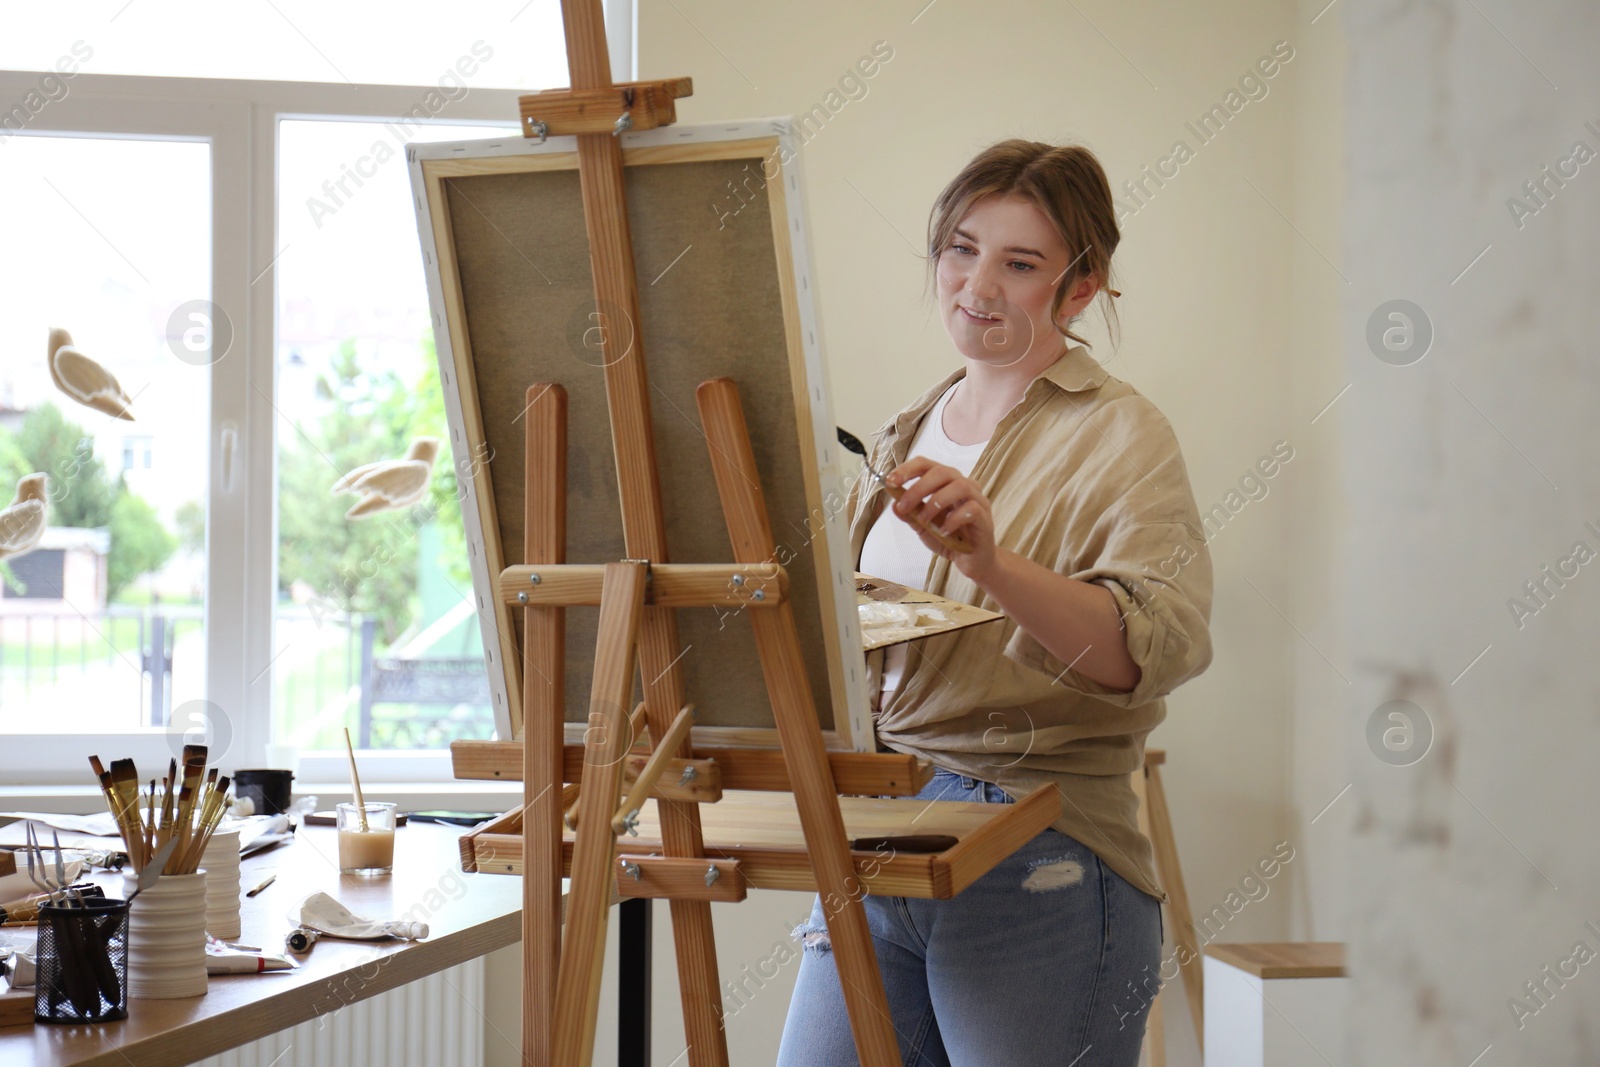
[490,0,1344,1067]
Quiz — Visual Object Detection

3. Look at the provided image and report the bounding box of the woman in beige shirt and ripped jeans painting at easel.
[779,139,1211,1067]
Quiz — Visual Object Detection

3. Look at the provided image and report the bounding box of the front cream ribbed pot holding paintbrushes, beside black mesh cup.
[123,869,206,1000]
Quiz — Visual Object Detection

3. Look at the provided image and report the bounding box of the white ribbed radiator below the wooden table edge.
[200,958,483,1067]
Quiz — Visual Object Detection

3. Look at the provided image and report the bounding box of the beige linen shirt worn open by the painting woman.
[848,346,1211,899]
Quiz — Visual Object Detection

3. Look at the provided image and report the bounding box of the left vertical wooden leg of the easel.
[522,382,566,1067]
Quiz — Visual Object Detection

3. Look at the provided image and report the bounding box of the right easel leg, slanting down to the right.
[694,378,901,1067]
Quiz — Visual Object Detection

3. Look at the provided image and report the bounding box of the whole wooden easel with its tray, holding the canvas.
[446,0,1059,1067]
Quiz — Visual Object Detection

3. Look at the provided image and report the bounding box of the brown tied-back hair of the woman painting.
[928,138,1122,346]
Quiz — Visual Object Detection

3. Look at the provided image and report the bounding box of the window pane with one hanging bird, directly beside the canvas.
[272,120,517,750]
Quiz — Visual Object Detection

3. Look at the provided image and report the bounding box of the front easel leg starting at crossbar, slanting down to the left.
[550,563,650,1067]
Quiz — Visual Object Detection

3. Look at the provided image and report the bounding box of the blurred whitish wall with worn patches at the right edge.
[1336,0,1600,1067]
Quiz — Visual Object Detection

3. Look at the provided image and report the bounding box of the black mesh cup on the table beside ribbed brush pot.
[34,897,128,1022]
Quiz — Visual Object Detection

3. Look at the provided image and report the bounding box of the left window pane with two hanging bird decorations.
[0,136,211,733]
